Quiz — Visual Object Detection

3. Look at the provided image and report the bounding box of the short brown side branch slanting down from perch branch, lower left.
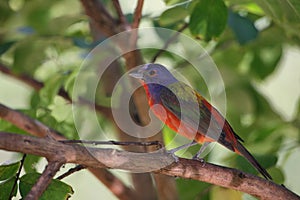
[25,161,63,200]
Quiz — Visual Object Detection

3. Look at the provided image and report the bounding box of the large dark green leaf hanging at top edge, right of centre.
[189,0,227,41]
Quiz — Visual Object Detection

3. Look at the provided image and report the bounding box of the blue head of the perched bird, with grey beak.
[129,63,178,86]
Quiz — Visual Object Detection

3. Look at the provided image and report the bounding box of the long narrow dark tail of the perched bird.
[235,141,272,180]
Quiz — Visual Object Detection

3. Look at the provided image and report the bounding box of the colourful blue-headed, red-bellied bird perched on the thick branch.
[129,63,272,180]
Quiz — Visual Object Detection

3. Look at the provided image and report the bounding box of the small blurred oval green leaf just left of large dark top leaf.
[159,6,189,26]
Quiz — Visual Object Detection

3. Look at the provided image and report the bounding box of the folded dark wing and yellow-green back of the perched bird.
[160,82,222,141]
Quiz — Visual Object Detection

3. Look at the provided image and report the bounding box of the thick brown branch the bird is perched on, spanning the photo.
[0,132,300,200]
